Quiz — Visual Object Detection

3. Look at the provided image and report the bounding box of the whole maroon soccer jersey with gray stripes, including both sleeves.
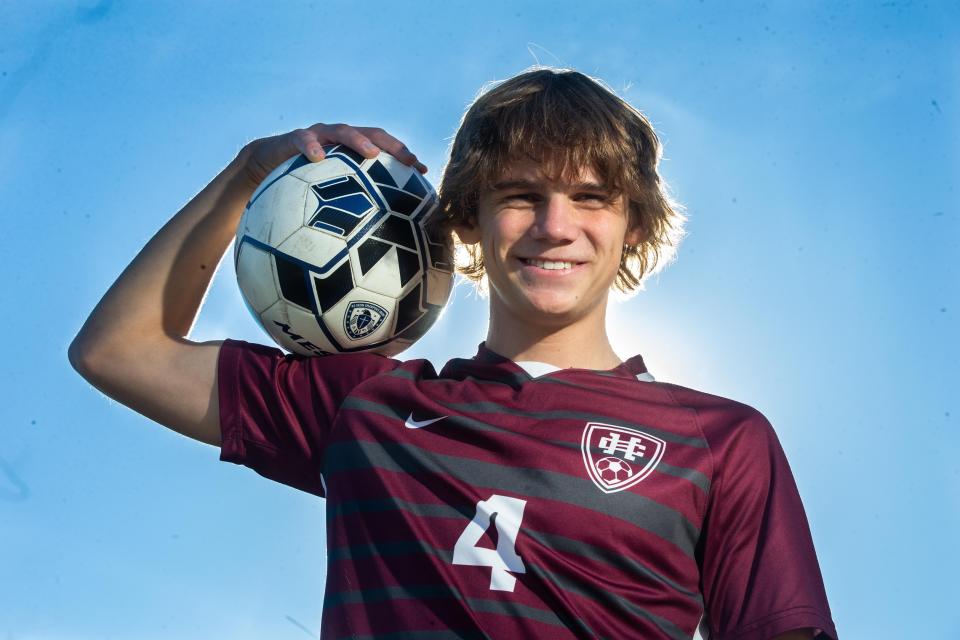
[219,341,836,640]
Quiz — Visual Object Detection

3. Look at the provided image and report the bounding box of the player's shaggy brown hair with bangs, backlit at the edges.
[439,68,686,293]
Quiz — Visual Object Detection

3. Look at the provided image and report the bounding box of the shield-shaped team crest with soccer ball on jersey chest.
[580,422,667,493]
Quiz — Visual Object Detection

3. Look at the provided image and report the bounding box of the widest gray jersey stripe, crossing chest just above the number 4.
[323,440,700,558]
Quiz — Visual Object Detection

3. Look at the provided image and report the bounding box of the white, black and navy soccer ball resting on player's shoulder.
[234,145,453,356]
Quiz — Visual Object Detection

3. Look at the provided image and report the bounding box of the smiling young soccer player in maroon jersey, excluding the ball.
[70,70,836,640]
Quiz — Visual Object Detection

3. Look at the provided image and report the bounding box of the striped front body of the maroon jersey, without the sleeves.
[322,350,711,638]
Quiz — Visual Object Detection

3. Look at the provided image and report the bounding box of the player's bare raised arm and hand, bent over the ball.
[69,124,426,446]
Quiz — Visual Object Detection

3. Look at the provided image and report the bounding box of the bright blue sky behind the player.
[0,1,960,640]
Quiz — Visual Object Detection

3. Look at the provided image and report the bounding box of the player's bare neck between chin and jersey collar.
[486,301,621,370]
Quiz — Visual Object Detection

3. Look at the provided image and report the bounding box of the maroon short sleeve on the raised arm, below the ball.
[217,340,400,496]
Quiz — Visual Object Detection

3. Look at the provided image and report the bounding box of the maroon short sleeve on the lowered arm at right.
[698,410,837,640]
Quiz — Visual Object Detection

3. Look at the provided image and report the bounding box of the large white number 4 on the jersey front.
[453,494,527,591]
